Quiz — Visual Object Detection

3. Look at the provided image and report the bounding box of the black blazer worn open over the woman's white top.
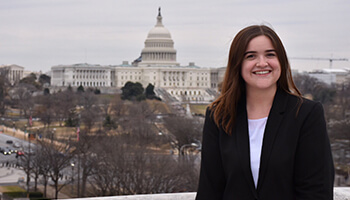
[196,90,334,200]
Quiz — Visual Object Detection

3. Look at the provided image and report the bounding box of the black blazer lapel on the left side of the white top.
[234,97,258,198]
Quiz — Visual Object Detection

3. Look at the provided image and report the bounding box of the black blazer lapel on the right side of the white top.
[257,89,288,190]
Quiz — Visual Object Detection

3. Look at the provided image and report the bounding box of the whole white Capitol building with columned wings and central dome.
[51,9,225,102]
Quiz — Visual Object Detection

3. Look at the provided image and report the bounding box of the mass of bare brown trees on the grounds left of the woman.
[0,69,203,198]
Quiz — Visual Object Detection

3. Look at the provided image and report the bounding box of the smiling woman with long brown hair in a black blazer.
[196,25,334,200]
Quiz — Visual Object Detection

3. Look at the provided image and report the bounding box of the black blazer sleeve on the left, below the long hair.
[196,109,225,200]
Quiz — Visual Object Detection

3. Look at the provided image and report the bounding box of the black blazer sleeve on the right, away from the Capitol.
[294,103,334,200]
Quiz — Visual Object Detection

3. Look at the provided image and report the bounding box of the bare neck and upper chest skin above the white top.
[246,88,277,119]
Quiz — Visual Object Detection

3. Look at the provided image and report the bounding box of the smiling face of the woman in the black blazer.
[241,35,281,90]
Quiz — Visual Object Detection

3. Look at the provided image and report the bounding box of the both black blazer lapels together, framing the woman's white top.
[233,89,288,198]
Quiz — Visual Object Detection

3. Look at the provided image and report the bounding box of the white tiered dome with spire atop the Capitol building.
[138,8,179,66]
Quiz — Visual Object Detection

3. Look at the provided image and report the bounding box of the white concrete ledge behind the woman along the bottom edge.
[67,187,350,200]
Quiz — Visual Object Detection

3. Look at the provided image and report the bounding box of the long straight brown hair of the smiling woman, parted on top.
[209,25,302,135]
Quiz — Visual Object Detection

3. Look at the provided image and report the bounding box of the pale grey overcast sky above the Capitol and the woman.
[0,0,350,72]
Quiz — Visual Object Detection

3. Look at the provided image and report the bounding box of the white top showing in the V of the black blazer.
[248,117,267,187]
